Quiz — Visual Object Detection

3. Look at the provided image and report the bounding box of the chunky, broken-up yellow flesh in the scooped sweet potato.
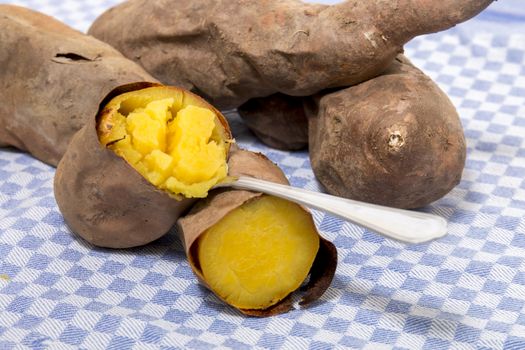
[99,88,227,198]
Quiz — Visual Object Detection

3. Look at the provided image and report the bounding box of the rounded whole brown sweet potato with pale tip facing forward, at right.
[307,55,466,208]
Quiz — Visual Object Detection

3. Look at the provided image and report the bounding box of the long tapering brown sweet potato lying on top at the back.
[89,0,493,109]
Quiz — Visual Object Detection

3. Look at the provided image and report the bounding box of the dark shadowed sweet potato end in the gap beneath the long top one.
[237,94,308,151]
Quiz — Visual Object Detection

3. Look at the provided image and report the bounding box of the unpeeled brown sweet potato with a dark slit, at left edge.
[0,5,156,166]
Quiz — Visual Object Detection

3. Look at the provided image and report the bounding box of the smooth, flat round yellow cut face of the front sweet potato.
[197,196,319,309]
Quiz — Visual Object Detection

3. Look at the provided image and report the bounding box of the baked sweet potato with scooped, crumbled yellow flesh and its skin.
[54,83,231,248]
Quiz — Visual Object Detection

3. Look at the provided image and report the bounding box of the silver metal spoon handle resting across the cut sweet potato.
[227,176,447,243]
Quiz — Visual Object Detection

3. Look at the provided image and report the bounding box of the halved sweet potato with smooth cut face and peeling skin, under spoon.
[178,149,337,316]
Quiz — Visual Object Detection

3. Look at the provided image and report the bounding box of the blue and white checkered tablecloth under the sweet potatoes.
[0,0,525,349]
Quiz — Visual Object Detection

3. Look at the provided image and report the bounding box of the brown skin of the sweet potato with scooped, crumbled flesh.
[54,82,230,248]
